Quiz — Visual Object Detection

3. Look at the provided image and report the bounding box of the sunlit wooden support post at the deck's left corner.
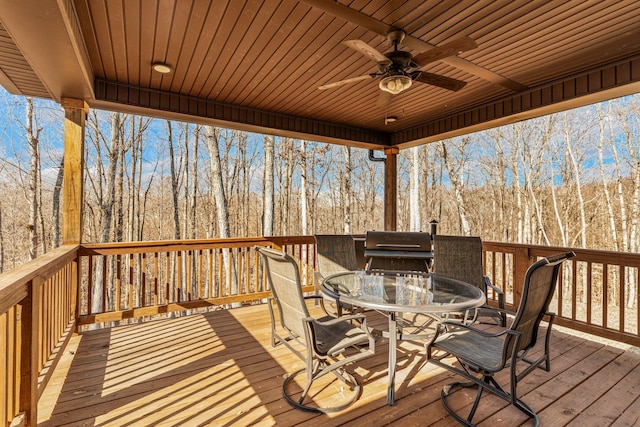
[62,98,89,244]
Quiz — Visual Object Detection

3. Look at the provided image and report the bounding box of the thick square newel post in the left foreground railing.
[18,276,42,426]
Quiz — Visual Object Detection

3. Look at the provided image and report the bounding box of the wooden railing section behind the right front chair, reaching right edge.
[483,242,640,346]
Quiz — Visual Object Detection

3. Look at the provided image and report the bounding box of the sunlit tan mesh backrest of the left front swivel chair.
[257,248,309,340]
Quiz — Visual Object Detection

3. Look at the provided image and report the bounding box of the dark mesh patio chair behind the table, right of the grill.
[433,234,507,326]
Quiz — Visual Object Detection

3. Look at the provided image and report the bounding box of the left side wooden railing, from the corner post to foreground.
[0,246,78,426]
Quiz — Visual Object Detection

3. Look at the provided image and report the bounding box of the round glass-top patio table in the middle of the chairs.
[322,270,485,405]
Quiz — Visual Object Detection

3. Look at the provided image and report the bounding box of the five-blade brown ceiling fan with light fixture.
[318,30,478,104]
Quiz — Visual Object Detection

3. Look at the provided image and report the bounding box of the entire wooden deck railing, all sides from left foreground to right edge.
[0,236,640,425]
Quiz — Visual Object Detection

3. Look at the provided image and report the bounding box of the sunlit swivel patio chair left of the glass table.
[256,247,375,413]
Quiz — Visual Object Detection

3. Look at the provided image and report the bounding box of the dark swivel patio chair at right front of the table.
[426,252,575,426]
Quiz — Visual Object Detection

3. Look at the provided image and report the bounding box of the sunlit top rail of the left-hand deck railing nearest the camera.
[0,245,79,315]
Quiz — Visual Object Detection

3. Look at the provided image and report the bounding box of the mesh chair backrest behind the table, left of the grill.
[315,234,358,277]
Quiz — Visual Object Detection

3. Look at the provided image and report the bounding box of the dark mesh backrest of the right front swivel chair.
[507,252,575,354]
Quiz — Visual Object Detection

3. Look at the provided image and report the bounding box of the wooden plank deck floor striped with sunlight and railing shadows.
[39,306,640,427]
